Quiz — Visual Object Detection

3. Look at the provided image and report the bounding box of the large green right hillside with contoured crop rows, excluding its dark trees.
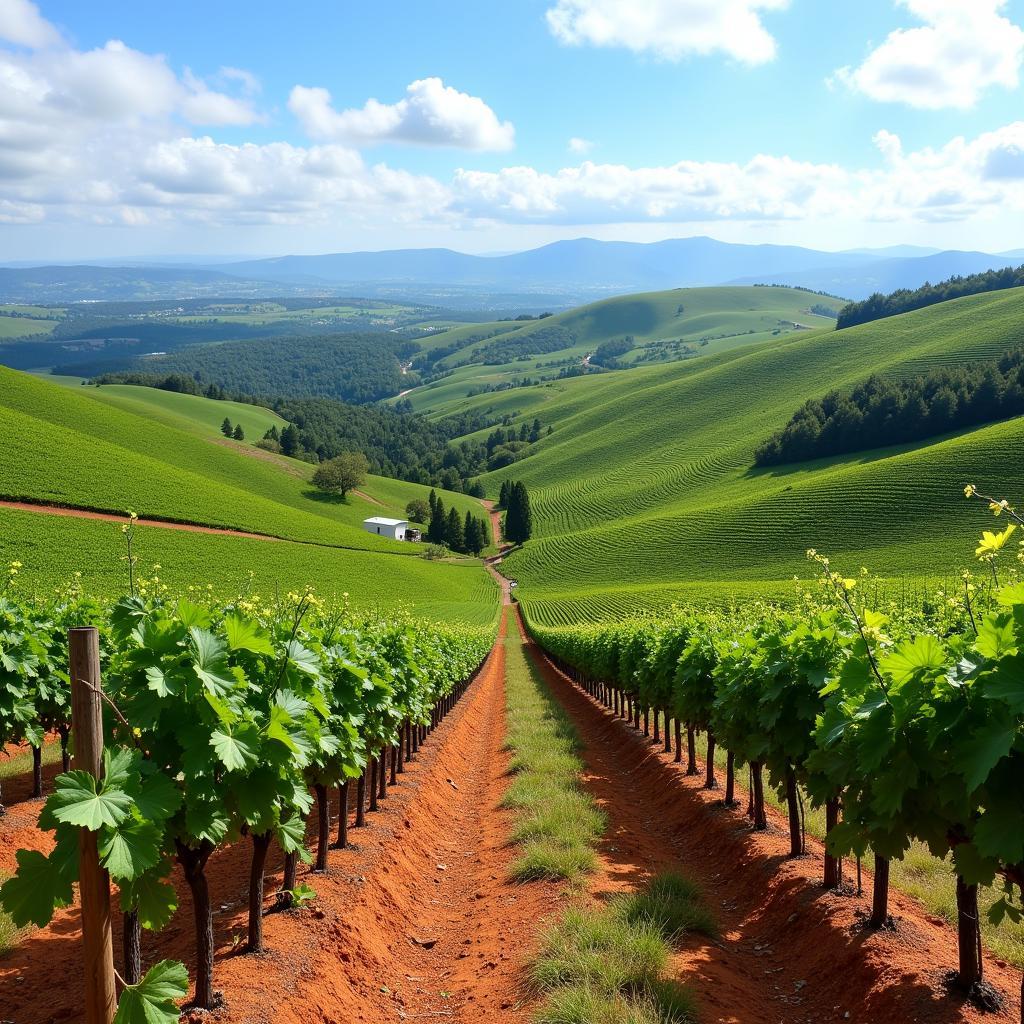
[495,290,1024,622]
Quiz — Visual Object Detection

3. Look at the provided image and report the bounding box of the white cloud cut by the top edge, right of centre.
[547,0,788,65]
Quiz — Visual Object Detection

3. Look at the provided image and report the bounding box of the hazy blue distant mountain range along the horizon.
[0,238,1024,308]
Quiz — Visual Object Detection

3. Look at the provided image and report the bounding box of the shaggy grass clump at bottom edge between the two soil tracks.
[530,874,716,1024]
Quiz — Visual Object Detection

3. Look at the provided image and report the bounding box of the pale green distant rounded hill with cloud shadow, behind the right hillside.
[399,287,844,415]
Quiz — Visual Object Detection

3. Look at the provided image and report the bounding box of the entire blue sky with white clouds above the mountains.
[0,0,1024,260]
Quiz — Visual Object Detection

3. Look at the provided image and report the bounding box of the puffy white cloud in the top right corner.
[835,0,1024,111]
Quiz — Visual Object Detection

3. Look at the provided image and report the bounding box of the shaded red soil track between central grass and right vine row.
[520,606,1020,1024]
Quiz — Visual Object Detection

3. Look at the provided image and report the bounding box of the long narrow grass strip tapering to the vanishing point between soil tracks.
[503,630,606,882]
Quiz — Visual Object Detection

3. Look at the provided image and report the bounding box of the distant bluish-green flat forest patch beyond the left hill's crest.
[136,334,420,404]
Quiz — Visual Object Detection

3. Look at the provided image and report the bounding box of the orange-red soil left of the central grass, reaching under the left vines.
[0,606,560,1024]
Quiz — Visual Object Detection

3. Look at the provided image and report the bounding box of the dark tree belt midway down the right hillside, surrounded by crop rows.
[754,349,1024,466]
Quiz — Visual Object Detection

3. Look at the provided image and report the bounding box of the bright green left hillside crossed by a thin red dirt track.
[0,368,496,618]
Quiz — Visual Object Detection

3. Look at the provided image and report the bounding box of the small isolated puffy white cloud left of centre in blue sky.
[288,78,515,151]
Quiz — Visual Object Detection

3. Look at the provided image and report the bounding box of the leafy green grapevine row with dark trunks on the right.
[531,548,1024,1009]
